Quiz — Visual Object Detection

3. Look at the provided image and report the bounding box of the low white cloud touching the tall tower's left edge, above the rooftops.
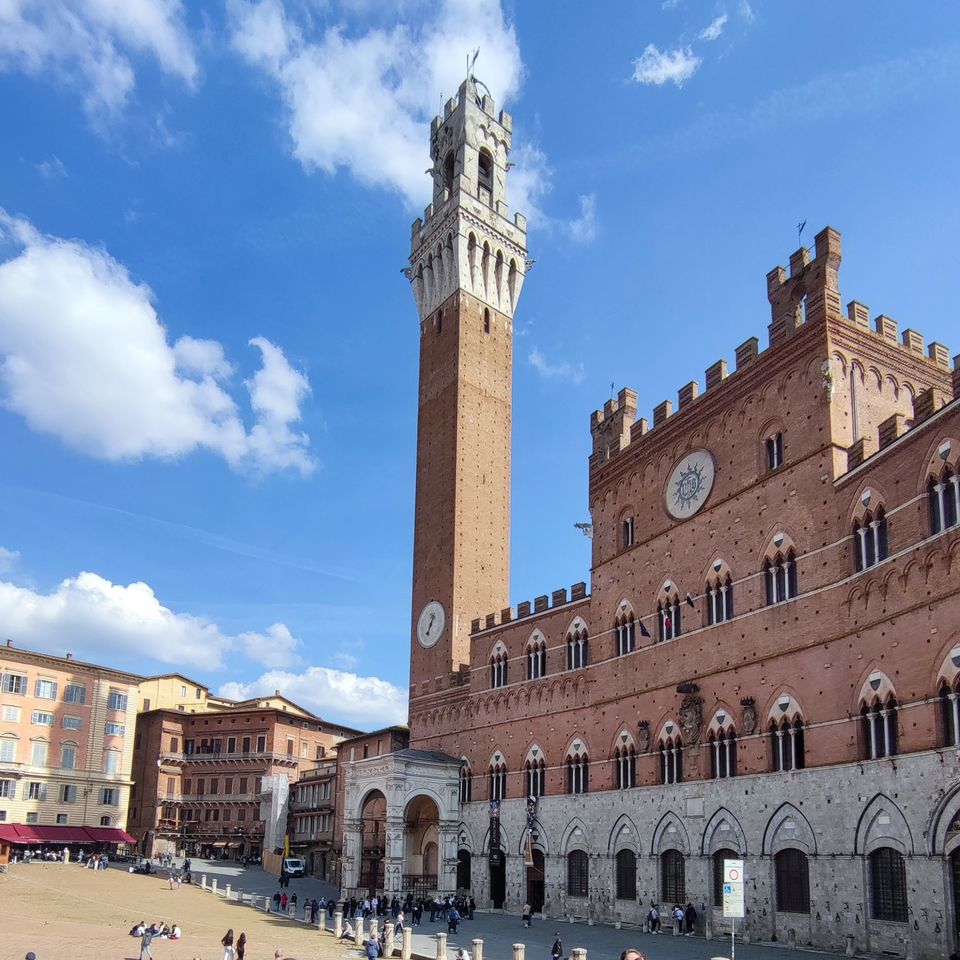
[219,667,407,728]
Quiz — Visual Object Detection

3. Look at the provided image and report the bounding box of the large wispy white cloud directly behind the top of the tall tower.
[228,0,526,212]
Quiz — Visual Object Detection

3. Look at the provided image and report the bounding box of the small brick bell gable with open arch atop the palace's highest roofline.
[767,227,843,347]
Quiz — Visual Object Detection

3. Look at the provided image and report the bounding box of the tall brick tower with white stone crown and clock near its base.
[405,76,527,699]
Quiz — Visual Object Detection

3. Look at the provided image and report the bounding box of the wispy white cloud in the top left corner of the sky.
[0,0,198,120]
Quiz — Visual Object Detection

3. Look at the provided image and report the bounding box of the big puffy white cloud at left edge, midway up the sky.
[0,210,314,475]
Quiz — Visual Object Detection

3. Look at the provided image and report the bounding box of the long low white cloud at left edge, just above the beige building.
[0,571,299,670]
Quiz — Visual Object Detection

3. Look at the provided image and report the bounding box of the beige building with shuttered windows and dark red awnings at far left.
[0,640,140,846]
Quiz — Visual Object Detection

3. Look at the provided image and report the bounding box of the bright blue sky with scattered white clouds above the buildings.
[0,0,960,727]
